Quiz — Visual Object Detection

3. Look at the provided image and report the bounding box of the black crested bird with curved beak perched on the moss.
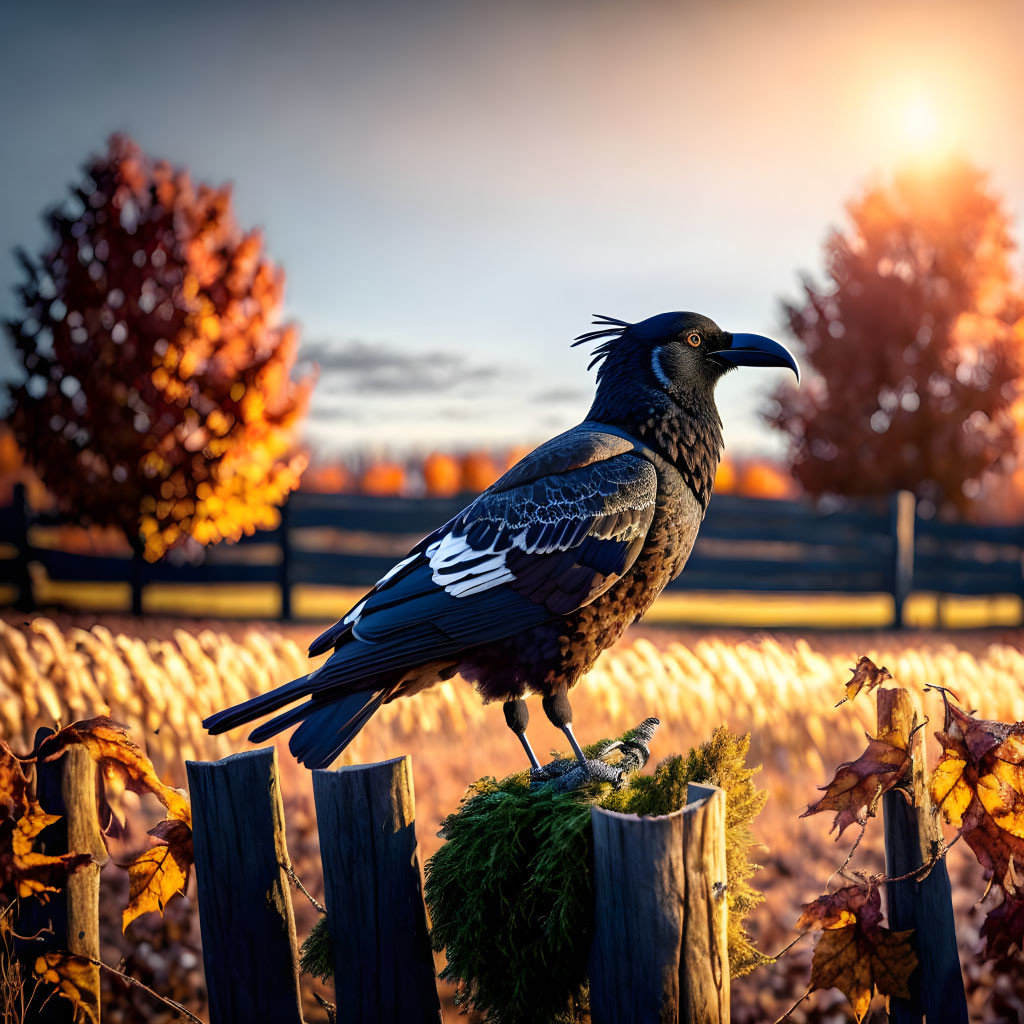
[204,312,800,772]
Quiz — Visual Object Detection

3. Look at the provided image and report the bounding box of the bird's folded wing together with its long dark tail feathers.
[204,432,657,767]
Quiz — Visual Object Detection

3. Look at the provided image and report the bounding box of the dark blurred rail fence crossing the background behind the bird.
[0,492,1024,626]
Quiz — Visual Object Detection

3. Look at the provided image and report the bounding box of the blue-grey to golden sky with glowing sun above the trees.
[0,0,1024,455]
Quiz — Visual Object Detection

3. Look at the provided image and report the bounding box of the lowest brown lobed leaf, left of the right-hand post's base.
[797,883,918,1022]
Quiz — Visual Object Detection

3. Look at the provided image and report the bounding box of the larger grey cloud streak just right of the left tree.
[300,339,507,395]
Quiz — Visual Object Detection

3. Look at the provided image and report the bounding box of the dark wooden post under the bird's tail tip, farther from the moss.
[185,746,302,1024]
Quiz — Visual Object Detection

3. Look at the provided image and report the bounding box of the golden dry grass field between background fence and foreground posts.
[0,613,1024,1024]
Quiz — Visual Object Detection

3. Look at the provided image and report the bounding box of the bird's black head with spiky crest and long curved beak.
[573,312,800,400]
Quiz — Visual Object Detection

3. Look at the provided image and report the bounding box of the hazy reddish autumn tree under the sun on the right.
[767,161,1024,510]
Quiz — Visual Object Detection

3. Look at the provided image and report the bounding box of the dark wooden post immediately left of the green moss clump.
[313,757,441,1024]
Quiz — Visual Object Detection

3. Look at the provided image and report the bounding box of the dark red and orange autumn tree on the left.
[6,136,310,559]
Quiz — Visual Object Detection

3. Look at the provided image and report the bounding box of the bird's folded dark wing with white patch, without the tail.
[310,435,657,663]
